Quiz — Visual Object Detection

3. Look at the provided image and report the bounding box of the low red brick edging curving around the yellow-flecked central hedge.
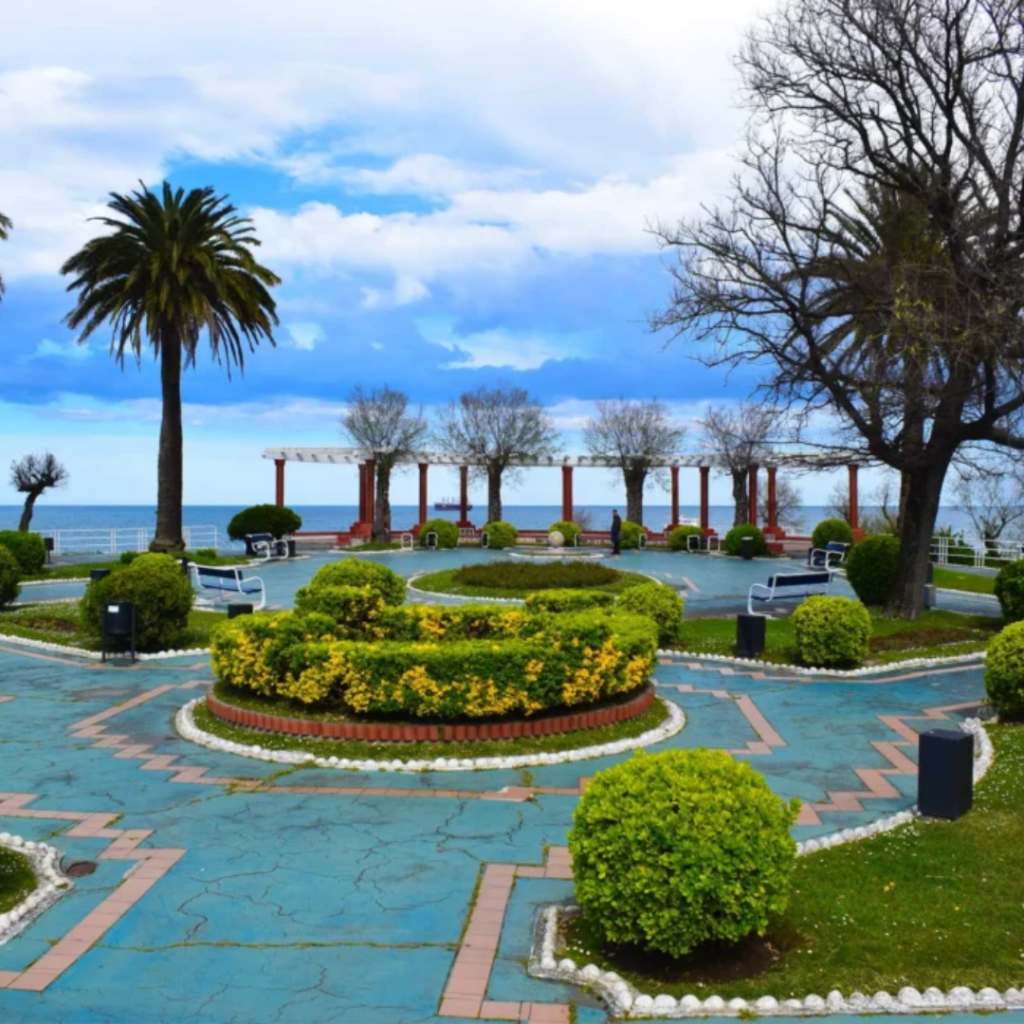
[206,683,654,743]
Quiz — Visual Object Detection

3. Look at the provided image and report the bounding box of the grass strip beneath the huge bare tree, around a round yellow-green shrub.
[676,610,1004,665]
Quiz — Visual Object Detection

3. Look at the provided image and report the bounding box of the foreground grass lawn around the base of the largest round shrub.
[565,725,1024,999]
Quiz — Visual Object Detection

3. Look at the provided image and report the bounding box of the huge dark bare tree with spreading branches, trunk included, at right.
[652,0,1024,617]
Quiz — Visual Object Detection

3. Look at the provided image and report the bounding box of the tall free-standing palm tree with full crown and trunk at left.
[61,181,280,551]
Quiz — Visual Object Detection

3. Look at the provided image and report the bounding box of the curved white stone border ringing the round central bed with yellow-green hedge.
[174,697,686,772]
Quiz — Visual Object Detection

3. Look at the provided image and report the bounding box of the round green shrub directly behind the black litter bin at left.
[79,554,196,651]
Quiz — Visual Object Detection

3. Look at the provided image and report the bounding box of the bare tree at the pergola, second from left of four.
[437,383,559,522]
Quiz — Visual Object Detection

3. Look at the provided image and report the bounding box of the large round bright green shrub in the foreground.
[568,750,800,957]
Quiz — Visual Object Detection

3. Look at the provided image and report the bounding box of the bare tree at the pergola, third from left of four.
[583,398,686,523]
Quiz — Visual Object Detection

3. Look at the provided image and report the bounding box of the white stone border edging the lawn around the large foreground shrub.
[528,718,999,1020]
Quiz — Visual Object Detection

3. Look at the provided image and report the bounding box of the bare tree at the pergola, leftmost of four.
[341,385,428,541]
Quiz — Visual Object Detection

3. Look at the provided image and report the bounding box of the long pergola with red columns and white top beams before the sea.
[263,447,863,539]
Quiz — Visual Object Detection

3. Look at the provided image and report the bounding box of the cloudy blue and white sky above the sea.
[0,0,880,505]
